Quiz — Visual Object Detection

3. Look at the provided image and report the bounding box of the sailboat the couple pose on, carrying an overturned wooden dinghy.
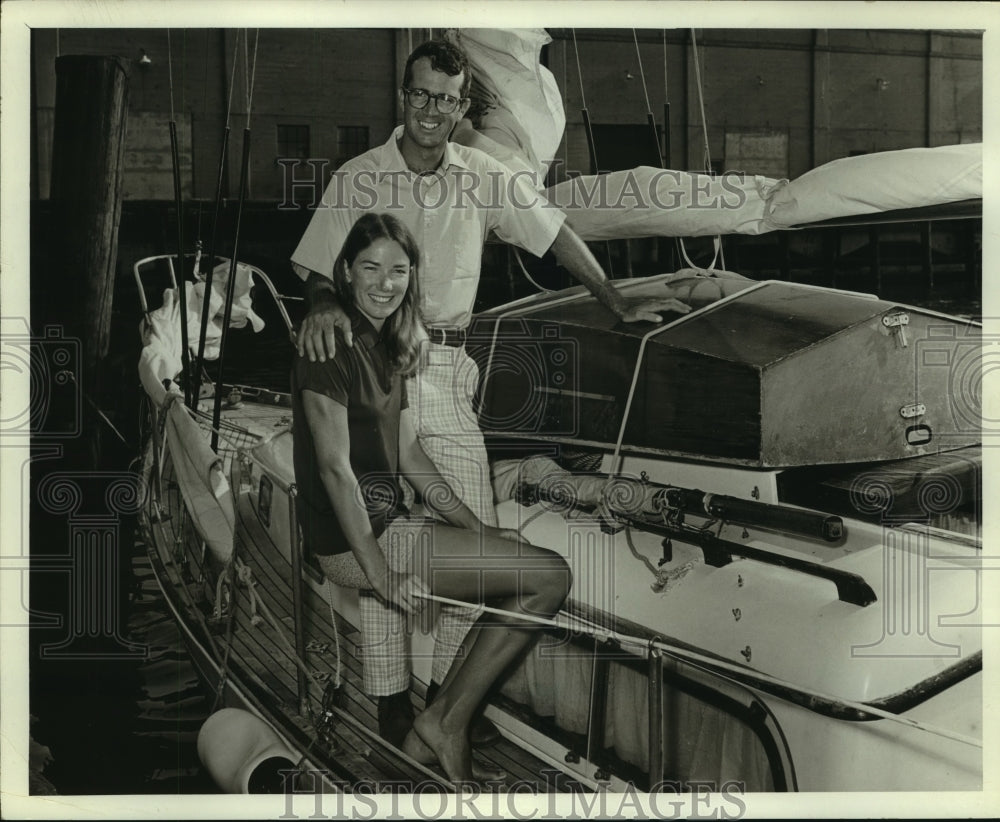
[134,30,983,793]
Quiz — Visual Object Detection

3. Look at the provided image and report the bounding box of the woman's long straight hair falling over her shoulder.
[333,211,427,376]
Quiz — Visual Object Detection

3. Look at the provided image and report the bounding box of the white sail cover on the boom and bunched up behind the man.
[456,29,983,241]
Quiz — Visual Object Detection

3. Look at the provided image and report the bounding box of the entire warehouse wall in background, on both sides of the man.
[32,29,983,201]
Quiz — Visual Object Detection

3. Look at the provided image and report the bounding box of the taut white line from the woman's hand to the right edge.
[416,594,983,748]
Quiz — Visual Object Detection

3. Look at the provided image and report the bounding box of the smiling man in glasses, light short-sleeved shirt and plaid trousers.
[292,41,689,745]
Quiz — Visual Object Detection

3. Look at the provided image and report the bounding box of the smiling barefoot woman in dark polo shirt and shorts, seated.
[292,213,571,781]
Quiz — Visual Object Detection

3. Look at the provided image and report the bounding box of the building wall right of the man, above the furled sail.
[546,29,983,177]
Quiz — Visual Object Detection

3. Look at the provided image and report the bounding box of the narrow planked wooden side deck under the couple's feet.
[146,402,587,792]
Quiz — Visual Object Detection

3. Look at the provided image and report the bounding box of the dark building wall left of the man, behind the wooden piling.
[33,29,399,201]
